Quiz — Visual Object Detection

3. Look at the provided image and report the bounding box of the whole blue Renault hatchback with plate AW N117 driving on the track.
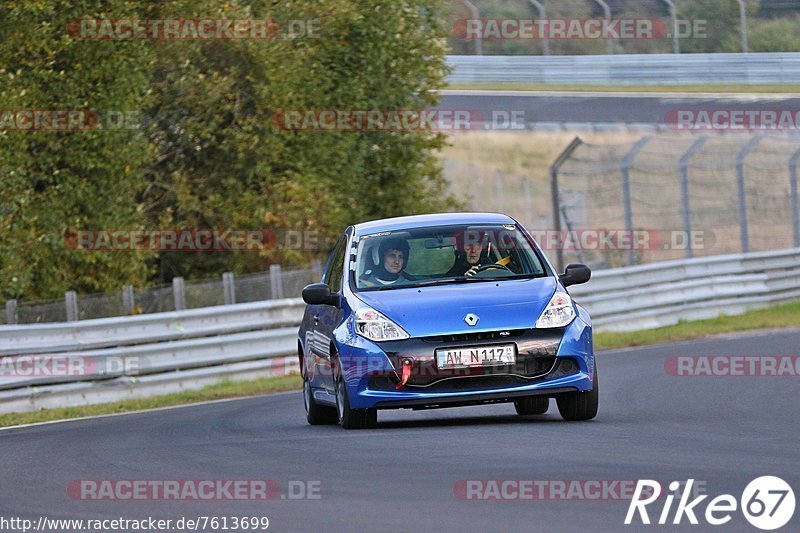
[298,213,598,429]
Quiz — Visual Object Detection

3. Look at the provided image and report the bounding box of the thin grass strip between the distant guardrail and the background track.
[447,83,800,94]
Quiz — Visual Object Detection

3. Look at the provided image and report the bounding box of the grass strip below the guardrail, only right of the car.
[594,302,800,350]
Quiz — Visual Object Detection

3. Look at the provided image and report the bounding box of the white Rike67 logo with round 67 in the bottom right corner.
[625,476,795,531]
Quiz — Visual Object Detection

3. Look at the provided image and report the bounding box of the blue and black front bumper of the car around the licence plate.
[339,313,595,409]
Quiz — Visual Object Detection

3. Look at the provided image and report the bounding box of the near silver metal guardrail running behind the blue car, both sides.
[0,248,800,412]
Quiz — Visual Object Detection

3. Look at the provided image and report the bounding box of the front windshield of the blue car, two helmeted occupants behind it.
[350,224,547,291]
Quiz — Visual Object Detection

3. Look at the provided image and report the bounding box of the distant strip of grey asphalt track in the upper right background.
[438,90,800,129]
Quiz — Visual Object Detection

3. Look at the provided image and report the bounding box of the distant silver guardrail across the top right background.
[447,53,800,85]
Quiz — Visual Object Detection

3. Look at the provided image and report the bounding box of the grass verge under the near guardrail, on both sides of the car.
[0,302,800,427]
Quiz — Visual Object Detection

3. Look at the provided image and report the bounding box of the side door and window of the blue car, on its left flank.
[306,235,347,393]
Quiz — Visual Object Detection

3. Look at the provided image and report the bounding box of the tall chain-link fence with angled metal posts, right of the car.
[554,134,800,268]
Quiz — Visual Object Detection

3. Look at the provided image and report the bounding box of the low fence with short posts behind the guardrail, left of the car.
[0,262,322,324]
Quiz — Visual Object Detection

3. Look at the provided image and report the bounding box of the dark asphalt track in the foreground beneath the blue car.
[0,330,800,532]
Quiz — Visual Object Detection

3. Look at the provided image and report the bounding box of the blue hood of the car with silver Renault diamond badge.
[356,277,557,337]
